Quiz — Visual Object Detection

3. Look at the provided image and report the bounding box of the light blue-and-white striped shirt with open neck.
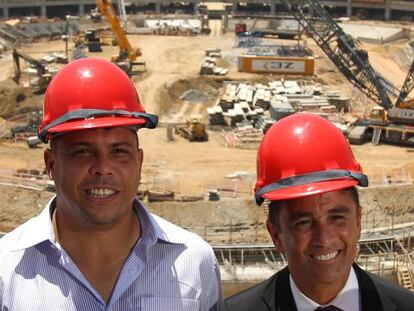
[0,200,221,311]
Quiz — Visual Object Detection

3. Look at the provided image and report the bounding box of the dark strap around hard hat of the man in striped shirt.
[38,109,158,143]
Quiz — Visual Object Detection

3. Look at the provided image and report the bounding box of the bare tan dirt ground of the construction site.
[0,20,414,240]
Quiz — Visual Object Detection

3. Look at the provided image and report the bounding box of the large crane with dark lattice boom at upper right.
[282,0,414,146]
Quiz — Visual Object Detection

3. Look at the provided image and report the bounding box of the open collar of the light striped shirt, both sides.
[11,196,185,251]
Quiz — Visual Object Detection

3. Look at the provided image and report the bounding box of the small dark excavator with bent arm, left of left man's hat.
[12,49,52,94]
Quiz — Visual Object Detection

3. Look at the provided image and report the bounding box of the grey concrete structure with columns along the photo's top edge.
[0,0,414,20]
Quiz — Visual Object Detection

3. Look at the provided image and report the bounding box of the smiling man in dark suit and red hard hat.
[222,113,414,311]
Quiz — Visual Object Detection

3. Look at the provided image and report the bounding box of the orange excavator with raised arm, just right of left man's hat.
[96,0,146,76]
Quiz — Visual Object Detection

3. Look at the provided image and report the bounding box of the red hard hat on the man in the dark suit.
[255,113,368,205]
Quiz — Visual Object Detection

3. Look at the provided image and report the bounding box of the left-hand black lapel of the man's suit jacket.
[262,267,297,311]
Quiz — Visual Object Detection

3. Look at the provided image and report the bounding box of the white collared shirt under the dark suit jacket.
[289,268,361,311]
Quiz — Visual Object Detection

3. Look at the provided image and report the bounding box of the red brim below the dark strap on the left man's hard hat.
[48,116,146,134]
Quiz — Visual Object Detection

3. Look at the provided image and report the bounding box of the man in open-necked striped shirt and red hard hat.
[0,58,221,311]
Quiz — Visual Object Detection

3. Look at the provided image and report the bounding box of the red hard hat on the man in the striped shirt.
[38,58,158,142]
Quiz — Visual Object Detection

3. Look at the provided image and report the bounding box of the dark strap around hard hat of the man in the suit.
[255,170,368,205]
